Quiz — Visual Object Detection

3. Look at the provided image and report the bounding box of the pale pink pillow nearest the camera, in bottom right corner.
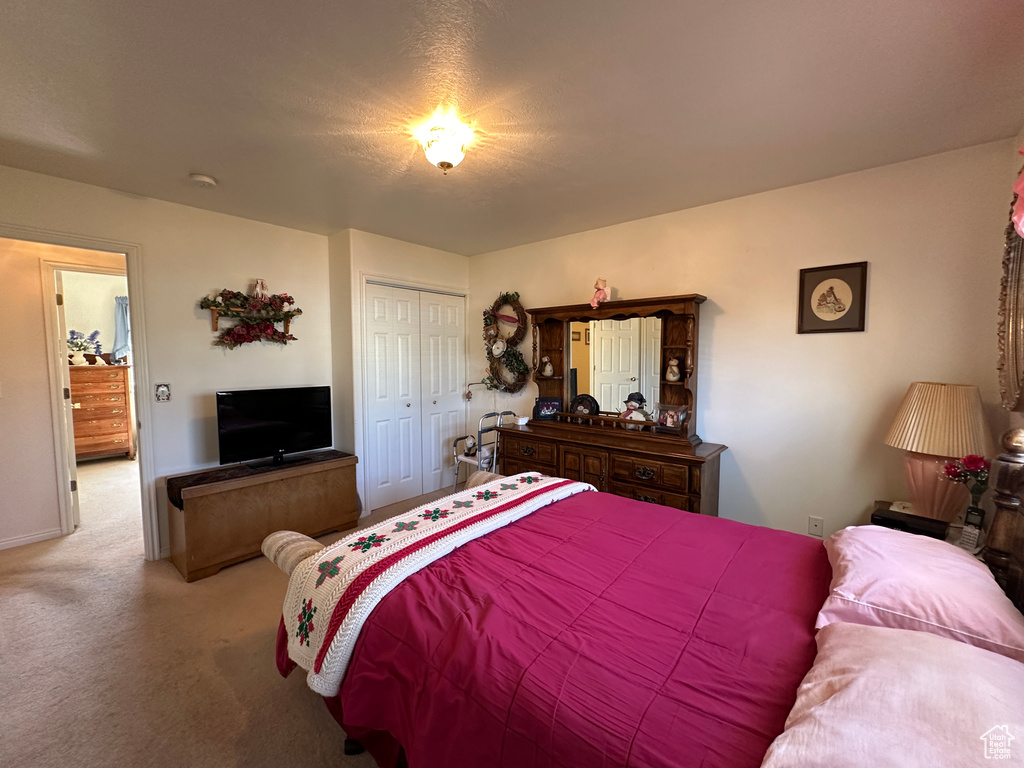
[761,626,1024,768]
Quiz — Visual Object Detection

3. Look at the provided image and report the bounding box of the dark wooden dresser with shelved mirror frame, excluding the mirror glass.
[498,294,726,516]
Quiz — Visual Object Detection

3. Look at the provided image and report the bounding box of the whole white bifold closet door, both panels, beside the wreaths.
[364,284,466,510]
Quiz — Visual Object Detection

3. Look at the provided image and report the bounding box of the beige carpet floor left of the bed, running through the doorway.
[0,460,452,768]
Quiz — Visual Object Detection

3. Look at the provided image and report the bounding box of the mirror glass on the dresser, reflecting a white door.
[568,317,662,414]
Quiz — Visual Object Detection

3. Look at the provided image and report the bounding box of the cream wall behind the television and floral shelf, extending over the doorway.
[0,166,331,552]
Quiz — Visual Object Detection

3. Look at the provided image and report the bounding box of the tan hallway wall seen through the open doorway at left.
[0,238,125,549]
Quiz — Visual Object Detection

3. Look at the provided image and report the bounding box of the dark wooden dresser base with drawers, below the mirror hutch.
[498,428,725,517]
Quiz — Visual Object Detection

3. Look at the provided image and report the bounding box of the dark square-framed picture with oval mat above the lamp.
[797,261,867,334]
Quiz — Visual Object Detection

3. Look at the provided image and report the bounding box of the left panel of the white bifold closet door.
[364,284,423,510]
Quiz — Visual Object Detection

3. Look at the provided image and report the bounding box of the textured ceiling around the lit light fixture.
[0,0,1024,255]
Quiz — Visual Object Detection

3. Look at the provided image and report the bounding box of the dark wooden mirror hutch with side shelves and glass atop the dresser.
[526,294,705,447]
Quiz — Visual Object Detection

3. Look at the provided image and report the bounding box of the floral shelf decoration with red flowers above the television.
[199,280,302,349]
